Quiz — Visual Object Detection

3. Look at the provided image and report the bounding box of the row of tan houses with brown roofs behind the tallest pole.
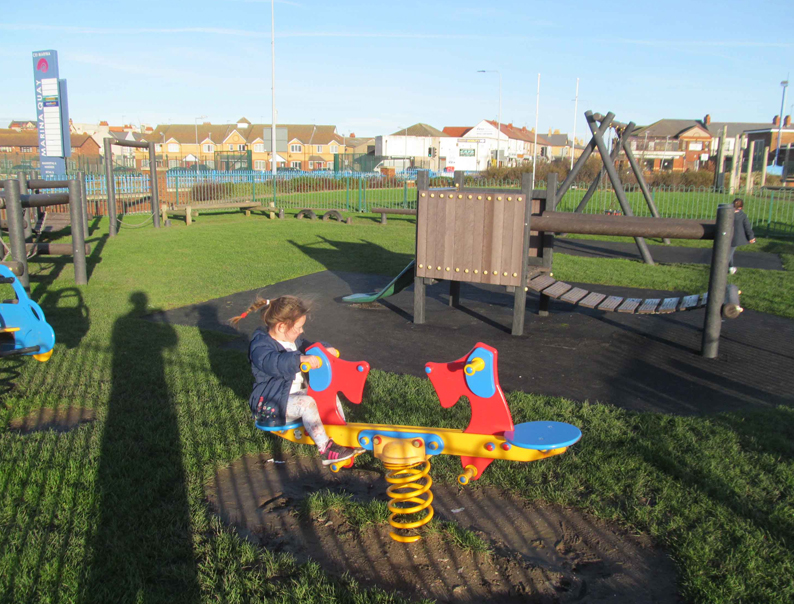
[136,117,344,171]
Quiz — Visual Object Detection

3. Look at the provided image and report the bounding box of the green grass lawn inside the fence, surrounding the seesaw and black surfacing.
[0,213,794,604]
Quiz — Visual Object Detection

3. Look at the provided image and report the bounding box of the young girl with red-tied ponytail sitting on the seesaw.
[230,296,363,466]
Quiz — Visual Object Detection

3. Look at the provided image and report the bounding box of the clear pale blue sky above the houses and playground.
[0,0,794,137]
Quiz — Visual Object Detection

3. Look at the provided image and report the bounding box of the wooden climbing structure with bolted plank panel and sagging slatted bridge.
[414,112,742,358]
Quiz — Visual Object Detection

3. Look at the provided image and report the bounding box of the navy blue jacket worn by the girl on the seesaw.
[248,327,314,423]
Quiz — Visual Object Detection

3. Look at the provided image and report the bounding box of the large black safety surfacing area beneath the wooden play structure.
[149,271,794,415]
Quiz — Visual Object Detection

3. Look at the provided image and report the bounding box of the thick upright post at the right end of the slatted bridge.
[701,203,734,359]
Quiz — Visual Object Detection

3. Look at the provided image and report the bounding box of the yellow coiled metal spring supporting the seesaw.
[384,460,433,543]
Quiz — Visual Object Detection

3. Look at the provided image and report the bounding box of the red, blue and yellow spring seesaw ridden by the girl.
[257,342,582,543]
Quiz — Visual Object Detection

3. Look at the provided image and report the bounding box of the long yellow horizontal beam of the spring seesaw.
[262,423,568,462]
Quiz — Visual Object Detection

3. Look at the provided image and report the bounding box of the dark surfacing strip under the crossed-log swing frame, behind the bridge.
[554,237,783,271]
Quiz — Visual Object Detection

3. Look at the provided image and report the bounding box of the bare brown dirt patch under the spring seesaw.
[206,455,680,604]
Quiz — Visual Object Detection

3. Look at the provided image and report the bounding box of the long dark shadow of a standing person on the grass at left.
[80,292,199,602]
